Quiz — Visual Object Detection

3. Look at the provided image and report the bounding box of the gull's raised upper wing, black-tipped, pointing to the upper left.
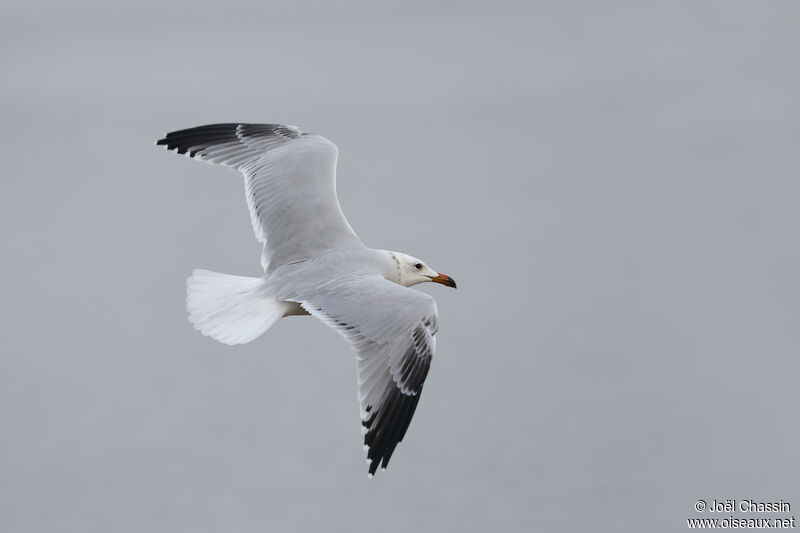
[156,123,361,270]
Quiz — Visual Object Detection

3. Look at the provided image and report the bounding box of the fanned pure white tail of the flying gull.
[186,270,290,344]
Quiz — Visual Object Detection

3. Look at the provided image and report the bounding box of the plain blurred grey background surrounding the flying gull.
[0,1,800,532]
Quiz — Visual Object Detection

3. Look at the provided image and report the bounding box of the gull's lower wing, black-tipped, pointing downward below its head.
[297,276,439,474]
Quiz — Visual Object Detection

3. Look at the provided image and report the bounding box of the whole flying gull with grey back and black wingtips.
[156,123,456,477]
